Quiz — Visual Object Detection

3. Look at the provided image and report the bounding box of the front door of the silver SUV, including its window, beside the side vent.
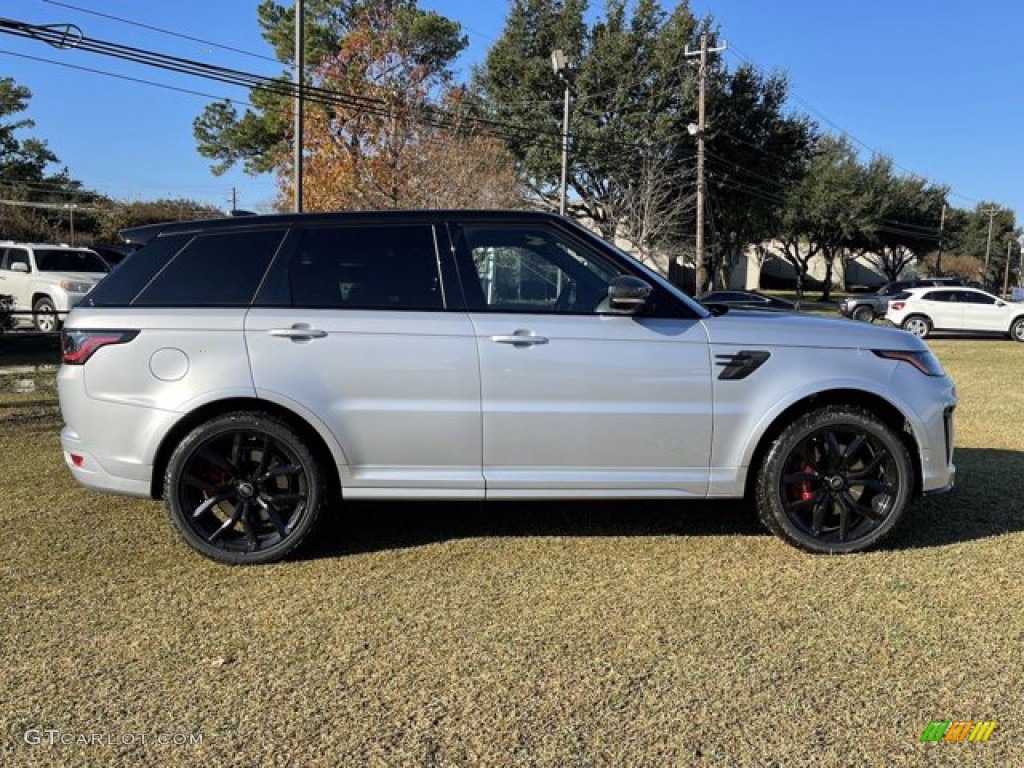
[455,223,712,498]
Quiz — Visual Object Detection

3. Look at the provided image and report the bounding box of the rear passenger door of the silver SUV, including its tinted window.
[246,222,483,499]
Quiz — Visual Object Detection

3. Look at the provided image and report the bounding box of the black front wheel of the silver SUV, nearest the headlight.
[756,406,914,554]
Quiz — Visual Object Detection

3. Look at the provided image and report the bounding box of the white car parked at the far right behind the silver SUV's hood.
[886,287,1024,342]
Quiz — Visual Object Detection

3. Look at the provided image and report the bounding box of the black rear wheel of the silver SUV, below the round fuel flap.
[164,411,327,565]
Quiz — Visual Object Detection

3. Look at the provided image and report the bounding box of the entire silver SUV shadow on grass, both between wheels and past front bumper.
[298,449,1024,559]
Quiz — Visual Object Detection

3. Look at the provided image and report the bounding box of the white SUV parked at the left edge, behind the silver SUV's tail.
[0,240,111,333]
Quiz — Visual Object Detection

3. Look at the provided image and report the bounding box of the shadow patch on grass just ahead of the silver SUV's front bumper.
[884,449,1024,550]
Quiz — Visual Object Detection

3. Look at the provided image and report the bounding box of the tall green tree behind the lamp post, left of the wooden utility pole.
[474,0,696,250]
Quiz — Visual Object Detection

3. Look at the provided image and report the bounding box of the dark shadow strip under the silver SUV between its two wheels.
[297,501,767,559]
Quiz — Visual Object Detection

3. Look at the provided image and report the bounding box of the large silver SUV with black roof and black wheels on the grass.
[58,211,956,563]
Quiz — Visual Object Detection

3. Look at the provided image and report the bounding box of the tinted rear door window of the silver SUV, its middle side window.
[289,225,444,310]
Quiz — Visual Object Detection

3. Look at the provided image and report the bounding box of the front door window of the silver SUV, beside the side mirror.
[463,226,623,314]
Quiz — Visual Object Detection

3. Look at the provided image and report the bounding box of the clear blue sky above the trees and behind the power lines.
[0,0,1024,223]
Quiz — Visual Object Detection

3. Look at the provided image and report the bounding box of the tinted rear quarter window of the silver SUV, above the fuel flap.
[133,229,285,306]
